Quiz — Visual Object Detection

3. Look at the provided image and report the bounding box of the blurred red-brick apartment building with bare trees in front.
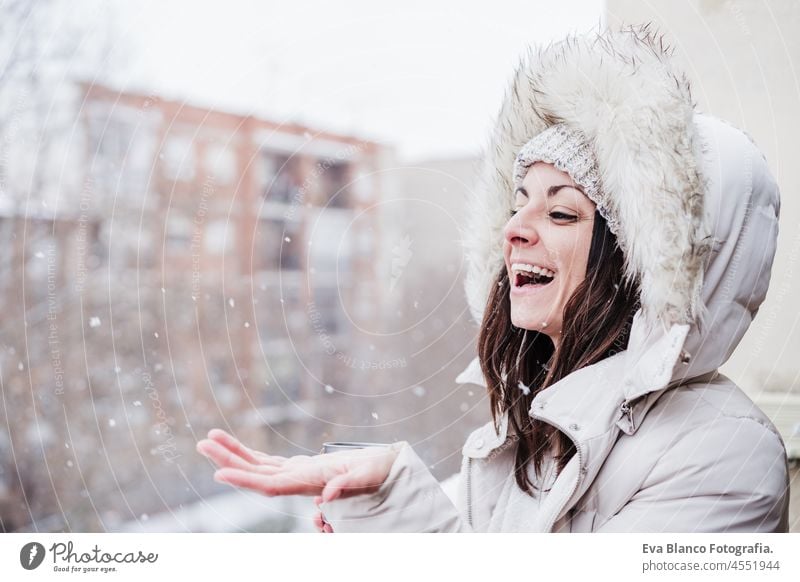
[0,85,391,531]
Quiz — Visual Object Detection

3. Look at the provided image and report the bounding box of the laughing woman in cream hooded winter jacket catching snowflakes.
[198,28,788,532]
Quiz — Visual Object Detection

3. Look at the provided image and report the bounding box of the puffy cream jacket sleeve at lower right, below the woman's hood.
[597,417,789,532]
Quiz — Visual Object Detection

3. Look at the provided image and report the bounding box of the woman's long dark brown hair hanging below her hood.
[478,211,639,494]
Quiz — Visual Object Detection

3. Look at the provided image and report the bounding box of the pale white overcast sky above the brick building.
[86,0,603,159]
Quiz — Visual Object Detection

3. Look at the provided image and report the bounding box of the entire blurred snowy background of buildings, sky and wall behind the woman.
[0,0,800,532]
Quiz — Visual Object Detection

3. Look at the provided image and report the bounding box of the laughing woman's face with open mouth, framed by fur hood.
[503,162,595,346]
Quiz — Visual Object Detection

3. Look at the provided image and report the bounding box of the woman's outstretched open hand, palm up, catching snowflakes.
[197,429,397,506]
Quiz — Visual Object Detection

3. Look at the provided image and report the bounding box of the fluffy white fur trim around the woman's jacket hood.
[462,27,710,327]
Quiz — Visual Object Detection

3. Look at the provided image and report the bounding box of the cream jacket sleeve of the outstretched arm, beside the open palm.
[320,441,472,533]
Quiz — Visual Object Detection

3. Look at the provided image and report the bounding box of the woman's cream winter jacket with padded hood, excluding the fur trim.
[321,30,789,533]
